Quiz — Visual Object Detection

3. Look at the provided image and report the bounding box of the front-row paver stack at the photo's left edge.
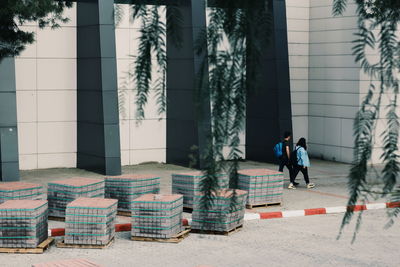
[0,200,48,248]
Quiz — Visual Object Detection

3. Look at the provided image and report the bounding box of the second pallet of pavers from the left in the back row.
[47,177,104,218]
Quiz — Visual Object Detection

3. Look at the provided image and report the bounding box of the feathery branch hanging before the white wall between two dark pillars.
[131,4,183,123]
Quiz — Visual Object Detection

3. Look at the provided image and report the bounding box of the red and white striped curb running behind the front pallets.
[49,202,400,236]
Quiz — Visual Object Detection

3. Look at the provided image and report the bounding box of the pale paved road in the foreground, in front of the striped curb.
[0,211,400,267]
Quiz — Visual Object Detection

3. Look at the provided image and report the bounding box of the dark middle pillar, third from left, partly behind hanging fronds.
[167,0,211,168]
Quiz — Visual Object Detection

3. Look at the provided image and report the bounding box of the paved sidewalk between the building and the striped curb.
[21,160,385,228]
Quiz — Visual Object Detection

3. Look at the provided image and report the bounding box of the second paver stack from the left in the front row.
[64,198,117,245]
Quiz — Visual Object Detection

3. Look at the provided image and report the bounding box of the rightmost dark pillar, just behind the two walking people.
[246,0,292,162]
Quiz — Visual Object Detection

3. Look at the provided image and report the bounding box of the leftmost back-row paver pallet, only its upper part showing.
[0,182,47,203]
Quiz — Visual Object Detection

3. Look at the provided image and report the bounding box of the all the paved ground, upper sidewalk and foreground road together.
[4,160,400,267]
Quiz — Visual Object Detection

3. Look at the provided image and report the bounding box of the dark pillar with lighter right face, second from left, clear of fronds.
[77,0,121,175]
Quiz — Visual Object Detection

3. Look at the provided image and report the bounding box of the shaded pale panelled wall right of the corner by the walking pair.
[309,0,370,162]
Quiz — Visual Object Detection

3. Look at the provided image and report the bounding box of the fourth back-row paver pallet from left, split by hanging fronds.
[172,172,229,209]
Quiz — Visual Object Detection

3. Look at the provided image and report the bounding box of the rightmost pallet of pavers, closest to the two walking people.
[238,169,284,208]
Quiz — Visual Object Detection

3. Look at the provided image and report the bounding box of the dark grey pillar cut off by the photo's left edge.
[0,58,19,181]
